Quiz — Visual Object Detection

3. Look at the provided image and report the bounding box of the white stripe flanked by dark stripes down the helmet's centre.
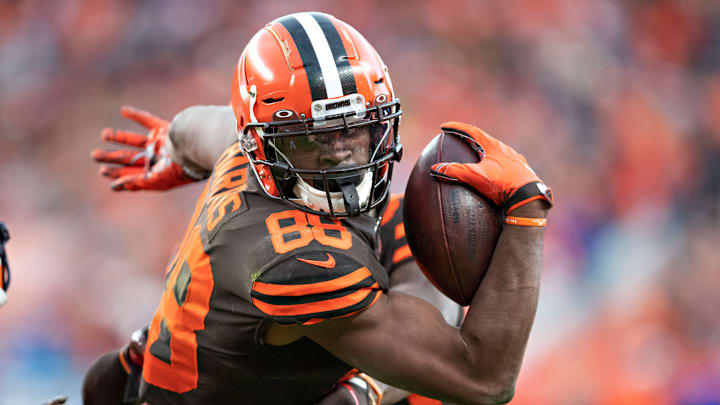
[278,13,357,100]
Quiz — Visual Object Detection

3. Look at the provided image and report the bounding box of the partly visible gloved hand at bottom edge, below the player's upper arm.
[317,372,382,405]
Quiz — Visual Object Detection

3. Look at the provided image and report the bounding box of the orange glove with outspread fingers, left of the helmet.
[92,106,205,191]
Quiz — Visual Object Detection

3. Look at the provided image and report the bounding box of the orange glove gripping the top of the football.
[431,122,553,214]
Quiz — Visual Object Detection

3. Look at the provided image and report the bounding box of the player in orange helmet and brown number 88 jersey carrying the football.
[84,13,551,404]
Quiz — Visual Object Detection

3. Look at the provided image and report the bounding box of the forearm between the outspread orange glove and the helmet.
[168,105,237,172]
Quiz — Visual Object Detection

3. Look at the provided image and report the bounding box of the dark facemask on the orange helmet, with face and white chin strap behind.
[243,100,402,218]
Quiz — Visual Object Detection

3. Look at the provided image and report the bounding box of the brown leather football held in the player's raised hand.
[403,133,502,305]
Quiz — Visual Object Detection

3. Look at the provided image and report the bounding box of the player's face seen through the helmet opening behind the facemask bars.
[275,127,370,170]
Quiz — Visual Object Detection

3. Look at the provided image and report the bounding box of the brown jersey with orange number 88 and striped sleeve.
[140,144,402,404]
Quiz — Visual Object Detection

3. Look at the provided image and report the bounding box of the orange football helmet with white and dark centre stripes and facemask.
[232,13,402,218]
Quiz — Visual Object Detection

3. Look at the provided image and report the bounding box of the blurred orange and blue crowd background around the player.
[0,0,720,405]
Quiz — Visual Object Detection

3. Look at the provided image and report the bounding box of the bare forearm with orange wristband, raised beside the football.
[461,201,547,401]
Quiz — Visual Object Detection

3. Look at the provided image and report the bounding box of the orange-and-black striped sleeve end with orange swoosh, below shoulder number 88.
[251,251,382,325]
